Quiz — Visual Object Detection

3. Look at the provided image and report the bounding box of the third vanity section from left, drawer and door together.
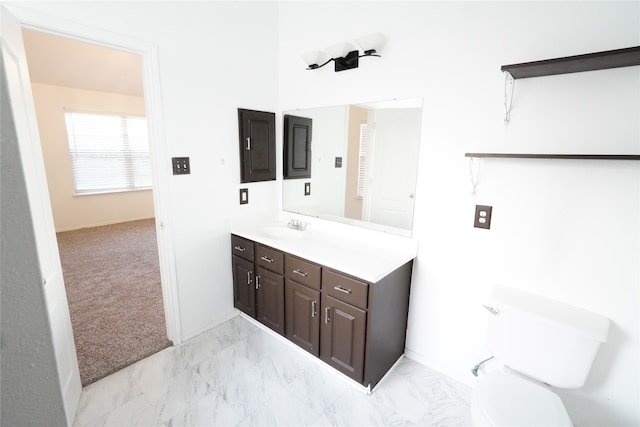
[285,254,322,356]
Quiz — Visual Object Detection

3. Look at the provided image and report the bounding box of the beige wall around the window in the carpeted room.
[31,83,154,231]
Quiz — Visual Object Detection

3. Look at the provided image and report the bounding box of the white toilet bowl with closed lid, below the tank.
[471,371,573,427]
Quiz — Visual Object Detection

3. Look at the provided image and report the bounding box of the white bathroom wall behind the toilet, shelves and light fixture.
[279,1,640,426]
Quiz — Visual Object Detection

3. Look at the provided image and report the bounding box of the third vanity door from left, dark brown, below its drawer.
[285,279,320,356]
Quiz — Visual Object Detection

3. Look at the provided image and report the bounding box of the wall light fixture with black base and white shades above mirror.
[302,33,384,72]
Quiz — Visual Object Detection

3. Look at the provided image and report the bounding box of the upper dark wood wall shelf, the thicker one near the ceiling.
[500,46,640,79]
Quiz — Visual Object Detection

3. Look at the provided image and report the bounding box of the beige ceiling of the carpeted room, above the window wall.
[23,30,143,96]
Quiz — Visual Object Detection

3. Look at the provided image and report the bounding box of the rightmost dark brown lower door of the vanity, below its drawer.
[320,295,367,383]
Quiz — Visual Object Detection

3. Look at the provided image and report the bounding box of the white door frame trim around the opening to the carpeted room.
[2,4,183,345]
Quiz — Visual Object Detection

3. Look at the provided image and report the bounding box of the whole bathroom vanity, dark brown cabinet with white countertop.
[231,223,417,389]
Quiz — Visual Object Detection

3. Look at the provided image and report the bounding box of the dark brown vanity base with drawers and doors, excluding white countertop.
[232,235,413,387]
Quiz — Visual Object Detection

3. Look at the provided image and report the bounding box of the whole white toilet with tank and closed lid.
[471,286,609,427]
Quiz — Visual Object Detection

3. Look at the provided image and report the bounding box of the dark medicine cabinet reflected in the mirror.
[283,115,313,179]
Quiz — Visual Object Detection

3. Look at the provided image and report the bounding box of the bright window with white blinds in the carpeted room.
[64,111,151,194]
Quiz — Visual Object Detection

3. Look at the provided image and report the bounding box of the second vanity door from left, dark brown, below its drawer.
[256,267,284,335]
